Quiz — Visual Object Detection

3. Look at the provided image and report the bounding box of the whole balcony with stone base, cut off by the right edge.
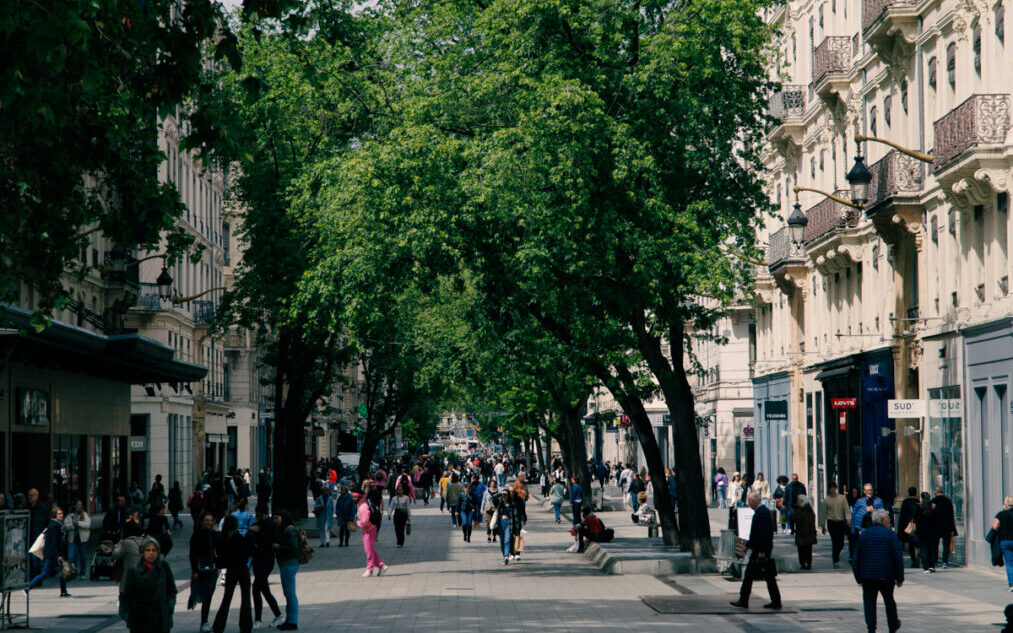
[932,94,1013,208]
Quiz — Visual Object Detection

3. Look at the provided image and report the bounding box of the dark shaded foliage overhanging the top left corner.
[0,0,292,315]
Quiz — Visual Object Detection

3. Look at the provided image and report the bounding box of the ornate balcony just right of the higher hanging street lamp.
[865,150,925,244]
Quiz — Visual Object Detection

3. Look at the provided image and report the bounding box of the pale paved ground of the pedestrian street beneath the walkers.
[12,488,1010,633]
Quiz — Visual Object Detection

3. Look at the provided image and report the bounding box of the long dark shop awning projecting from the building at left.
[0,304,208,385]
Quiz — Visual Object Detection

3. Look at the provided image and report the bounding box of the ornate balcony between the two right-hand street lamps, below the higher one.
[804,189,861,274]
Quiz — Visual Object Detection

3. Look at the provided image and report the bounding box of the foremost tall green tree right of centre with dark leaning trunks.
[380,0,771,556]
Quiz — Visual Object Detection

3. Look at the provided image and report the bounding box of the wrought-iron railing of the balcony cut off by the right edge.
[932,94,1010,172]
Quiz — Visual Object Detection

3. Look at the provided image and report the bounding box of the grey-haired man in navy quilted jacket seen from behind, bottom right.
[851,508,904,633]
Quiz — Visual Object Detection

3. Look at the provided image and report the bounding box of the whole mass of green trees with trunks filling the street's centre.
[9,0,774,556]
